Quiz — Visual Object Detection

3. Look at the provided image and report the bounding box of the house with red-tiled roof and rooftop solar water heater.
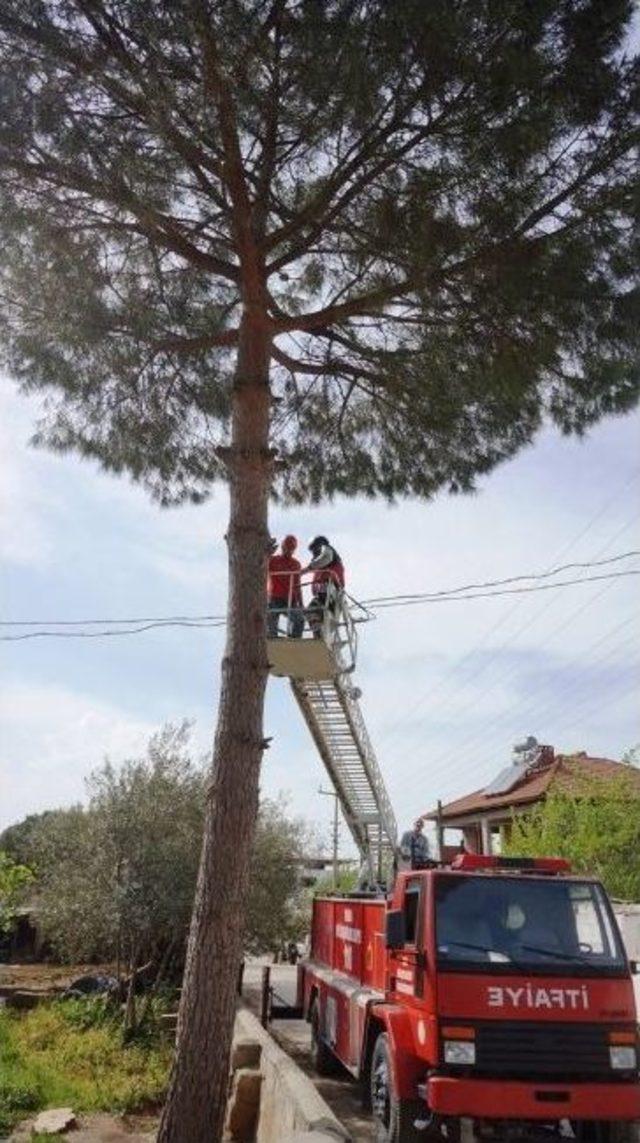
[425,738,640,854]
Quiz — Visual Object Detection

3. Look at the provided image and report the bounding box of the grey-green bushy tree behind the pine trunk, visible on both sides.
[0,724,312,967]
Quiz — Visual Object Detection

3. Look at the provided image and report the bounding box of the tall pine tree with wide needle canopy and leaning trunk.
[0,0,640,1143]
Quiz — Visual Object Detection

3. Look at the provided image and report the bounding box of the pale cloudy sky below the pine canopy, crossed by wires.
[0,379,640,854]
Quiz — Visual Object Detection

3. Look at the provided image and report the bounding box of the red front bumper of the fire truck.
[425,1076,640,1121]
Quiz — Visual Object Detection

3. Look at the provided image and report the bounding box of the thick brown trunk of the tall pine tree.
[158,307,271,1143]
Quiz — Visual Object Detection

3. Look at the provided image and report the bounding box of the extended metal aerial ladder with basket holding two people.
[267,592,398,885]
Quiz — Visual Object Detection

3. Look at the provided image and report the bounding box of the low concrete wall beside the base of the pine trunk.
[234,1008,351,1143]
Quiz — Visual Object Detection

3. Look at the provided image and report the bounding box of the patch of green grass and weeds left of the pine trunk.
[0,1000,171,1140]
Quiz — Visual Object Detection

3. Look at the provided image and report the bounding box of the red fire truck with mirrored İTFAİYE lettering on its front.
[298,854,640,1143]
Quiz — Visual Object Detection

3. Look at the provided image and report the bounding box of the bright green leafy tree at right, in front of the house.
[505,773,640,901]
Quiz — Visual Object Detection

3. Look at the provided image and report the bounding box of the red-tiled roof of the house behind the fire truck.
[424,753,640,822]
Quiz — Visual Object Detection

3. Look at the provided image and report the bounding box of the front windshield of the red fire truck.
[435,874,626,974]
